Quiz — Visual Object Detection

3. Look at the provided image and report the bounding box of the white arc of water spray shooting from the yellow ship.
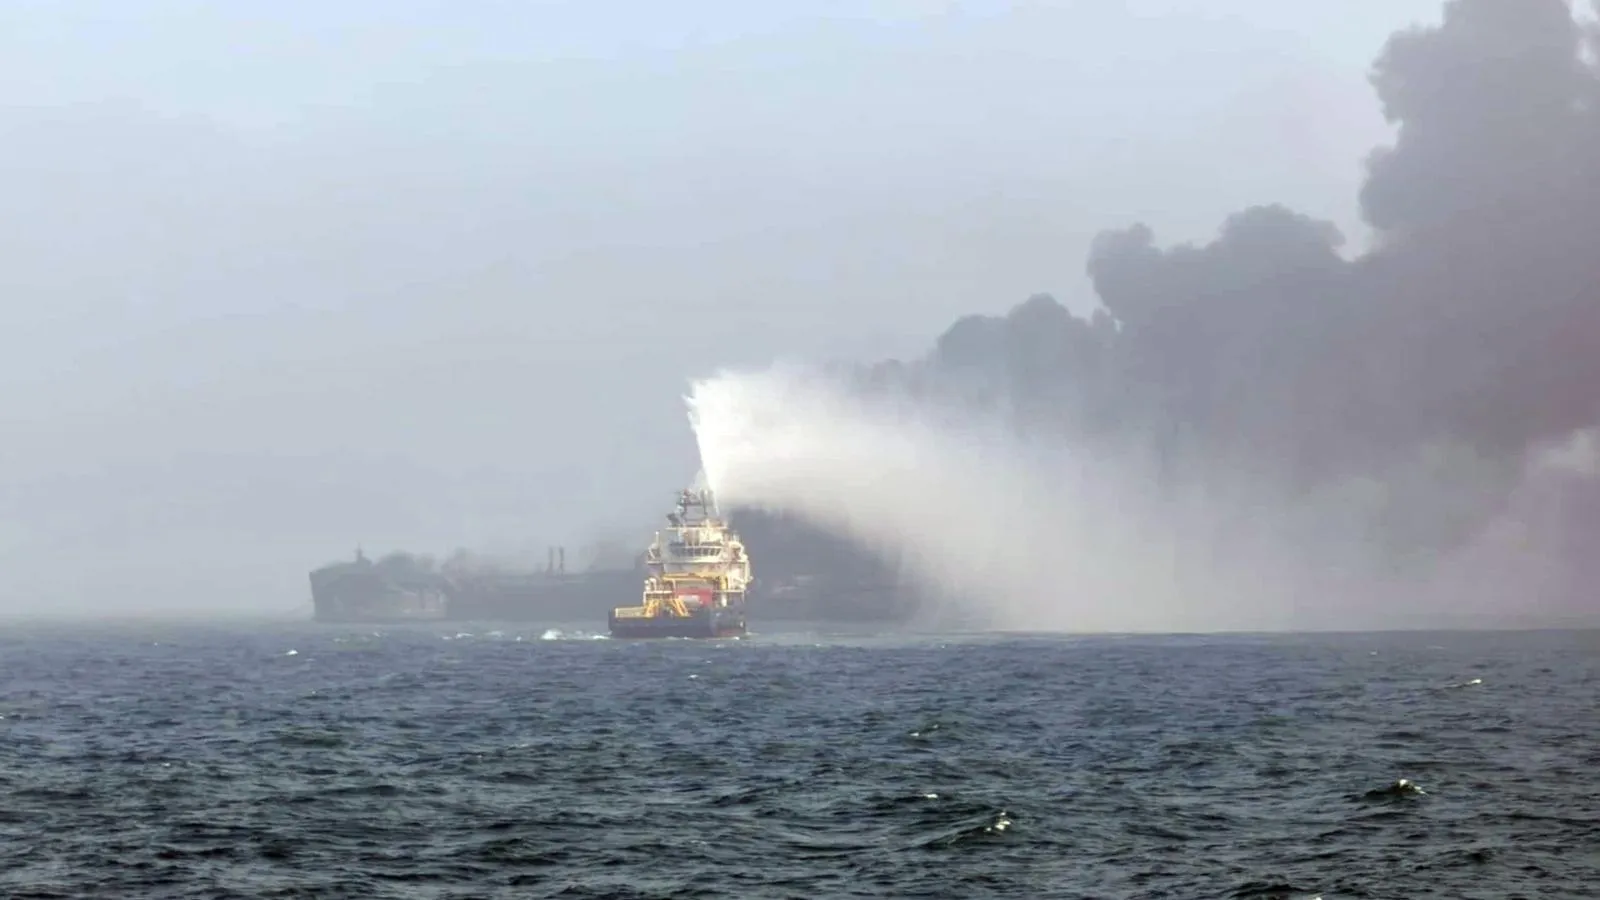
[688,360,1337,631]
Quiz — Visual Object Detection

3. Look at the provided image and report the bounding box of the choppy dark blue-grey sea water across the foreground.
[0,625,1600,900]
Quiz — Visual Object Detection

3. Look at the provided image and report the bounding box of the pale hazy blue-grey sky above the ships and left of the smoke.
[0,0,1438,610]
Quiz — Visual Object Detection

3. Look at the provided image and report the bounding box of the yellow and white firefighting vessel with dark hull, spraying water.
[610,490,750,637]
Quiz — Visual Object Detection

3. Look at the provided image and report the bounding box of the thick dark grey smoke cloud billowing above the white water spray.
[838,0,1600,612]
